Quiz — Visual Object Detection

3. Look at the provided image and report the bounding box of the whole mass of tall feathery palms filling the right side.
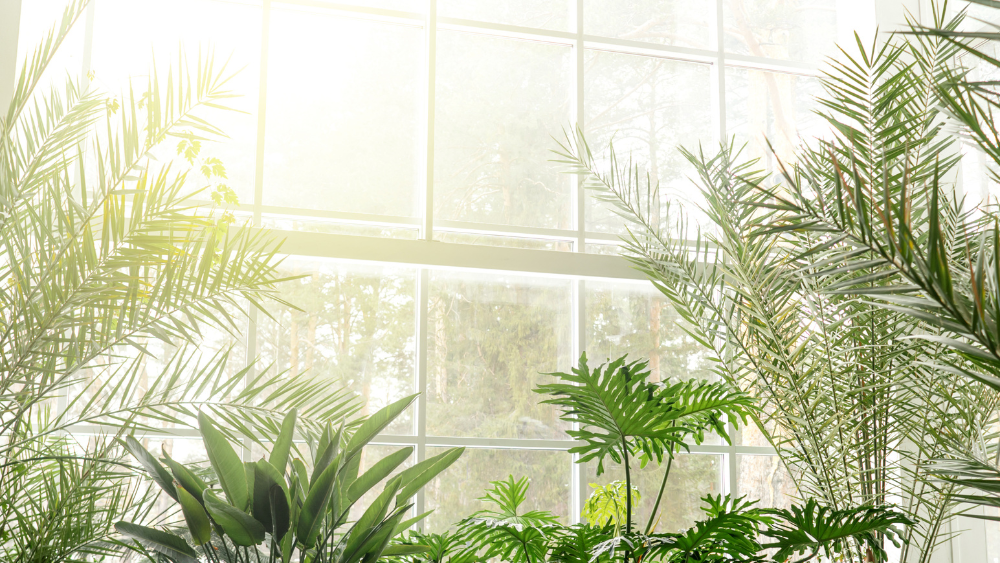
[557,0,1000,562]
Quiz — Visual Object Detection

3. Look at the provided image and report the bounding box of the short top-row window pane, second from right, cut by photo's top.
[583,0,715,48]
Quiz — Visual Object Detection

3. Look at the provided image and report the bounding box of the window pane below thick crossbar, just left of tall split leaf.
[427,272,572,439]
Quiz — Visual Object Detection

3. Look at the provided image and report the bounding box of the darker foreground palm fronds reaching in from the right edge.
[752,0,1000,519]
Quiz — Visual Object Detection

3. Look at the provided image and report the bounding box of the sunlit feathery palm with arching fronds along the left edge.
[0,0,357,561]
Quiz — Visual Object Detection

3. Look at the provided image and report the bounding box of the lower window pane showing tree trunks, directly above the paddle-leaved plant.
[257,259,416,434]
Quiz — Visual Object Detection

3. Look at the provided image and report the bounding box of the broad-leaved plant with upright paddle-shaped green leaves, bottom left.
[116,396,464,563]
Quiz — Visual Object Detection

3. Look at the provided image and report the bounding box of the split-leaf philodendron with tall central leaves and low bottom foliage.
[399,356,910,563]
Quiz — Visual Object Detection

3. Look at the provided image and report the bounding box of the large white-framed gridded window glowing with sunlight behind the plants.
[15,0,863,530]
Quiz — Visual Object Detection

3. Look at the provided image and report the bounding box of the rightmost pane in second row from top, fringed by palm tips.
[726,68,828,171]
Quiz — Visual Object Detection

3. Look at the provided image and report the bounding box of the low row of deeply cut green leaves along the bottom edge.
[397,477,911,563]
